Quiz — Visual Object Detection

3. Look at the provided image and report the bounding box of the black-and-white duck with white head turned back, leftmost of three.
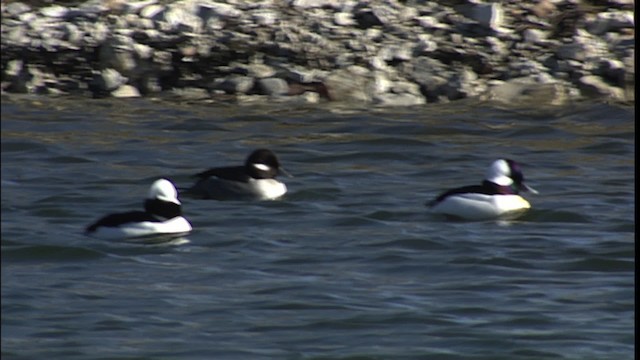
[85,179,192,240]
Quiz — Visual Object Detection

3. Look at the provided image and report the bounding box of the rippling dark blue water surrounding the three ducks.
[2,98,635,360]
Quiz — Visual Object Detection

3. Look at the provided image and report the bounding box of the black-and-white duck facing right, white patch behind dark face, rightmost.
[427,159,538,220]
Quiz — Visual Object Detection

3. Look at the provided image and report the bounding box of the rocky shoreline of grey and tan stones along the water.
[1,0,635,106]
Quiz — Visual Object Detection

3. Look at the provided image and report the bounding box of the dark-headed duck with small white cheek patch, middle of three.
[189,149,291,200]
